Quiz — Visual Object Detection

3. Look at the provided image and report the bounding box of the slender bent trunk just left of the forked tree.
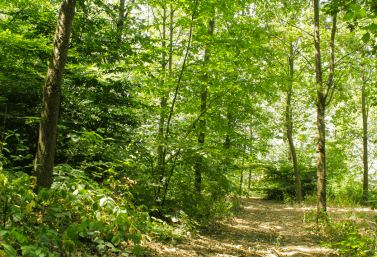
[286,43,302,203]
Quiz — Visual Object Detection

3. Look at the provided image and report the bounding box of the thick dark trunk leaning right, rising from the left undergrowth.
[34,0,76,192]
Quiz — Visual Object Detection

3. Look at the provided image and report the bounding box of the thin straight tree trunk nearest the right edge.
[361,73,368,203]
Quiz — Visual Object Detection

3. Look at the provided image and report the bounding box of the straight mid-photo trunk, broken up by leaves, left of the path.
[195,18,215,194]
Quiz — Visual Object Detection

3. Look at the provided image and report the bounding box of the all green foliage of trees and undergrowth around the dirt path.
[0,0,377,252]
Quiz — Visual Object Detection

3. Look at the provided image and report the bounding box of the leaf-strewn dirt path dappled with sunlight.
[148,198,334,257]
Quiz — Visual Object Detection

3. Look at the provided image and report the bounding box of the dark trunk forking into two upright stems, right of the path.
[314,0,337,217]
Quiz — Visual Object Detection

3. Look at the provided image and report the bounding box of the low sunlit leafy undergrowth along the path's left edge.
[0,165,239,254]
